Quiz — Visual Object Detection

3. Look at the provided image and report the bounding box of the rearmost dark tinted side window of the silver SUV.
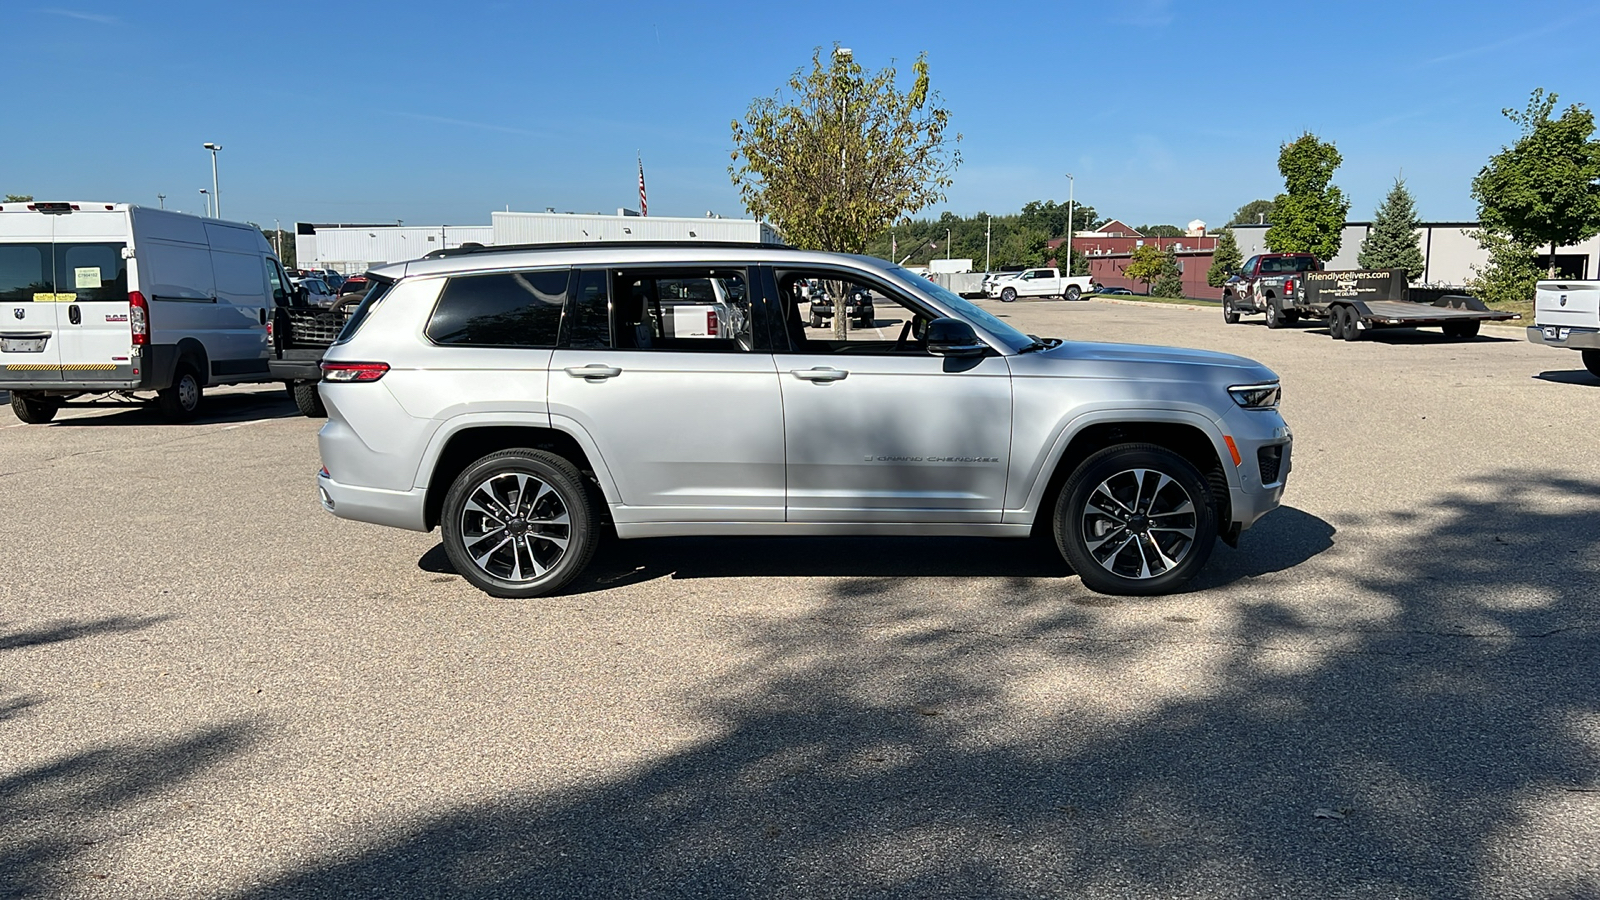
[426,269,571,348]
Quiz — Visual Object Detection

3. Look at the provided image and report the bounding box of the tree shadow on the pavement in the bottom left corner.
[0,724,254,898]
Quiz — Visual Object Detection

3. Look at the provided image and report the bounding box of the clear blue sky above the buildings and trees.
[9,0,1600,226]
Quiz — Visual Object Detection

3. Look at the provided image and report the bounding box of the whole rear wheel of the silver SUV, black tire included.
[440,447,600,599]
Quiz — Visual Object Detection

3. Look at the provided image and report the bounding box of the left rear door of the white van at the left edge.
[0,229,61,379]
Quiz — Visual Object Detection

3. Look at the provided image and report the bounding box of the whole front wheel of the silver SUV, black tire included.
[1053,444,1216,596]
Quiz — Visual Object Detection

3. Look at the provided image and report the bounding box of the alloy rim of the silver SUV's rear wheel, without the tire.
[461,472,573,583]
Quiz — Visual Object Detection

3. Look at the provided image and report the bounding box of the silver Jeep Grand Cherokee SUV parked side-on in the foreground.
[317,242,1290,597]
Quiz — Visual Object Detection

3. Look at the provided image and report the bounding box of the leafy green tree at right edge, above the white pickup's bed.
[1472,88,1600,277]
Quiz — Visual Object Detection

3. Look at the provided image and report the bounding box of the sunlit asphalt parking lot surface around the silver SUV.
[0,301,1600,898]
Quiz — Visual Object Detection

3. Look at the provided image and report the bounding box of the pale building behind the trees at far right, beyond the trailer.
[1229,223,1600,287]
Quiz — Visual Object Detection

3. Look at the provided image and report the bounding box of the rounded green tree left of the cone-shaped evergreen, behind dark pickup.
[1266,131,1350,259]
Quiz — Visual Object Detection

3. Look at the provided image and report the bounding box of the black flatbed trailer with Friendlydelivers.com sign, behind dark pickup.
[1293,269,1522,341]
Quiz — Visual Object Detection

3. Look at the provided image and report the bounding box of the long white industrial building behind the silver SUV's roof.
[294,210,782,274]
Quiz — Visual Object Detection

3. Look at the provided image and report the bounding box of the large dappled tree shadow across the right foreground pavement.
[321,472,1600,898]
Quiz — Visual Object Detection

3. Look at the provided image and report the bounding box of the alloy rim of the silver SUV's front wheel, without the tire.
[1078,469,1200,581]
